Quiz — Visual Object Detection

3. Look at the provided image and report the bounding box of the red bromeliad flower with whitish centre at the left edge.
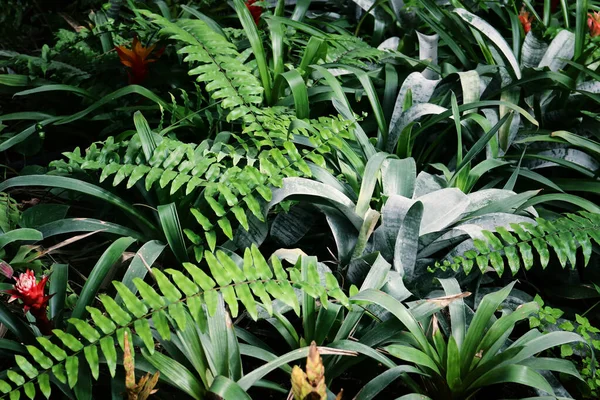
[0,262,52,335]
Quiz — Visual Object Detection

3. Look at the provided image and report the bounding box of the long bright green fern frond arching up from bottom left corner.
[0,245,350,399]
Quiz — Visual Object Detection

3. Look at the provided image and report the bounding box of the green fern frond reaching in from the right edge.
[434,211,600,276]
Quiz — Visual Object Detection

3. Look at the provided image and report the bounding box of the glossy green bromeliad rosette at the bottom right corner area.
[380,280,584,399]
